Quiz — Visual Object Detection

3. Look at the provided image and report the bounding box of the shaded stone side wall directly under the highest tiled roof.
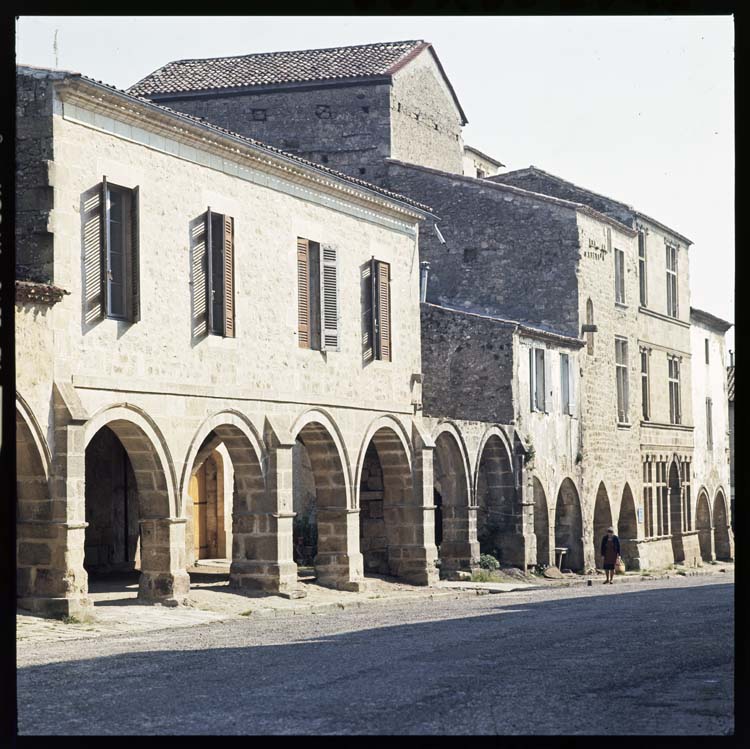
[152,83,391,183]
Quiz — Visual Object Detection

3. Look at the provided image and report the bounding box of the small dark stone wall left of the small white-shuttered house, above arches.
[422,304,513,424]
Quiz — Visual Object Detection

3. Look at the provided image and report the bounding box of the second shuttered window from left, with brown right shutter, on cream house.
[205,208,235,338]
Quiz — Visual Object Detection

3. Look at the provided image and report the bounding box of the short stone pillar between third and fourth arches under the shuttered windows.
[315,508,365,592]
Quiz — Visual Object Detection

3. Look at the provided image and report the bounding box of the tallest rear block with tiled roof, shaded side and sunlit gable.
[130,41,467,183]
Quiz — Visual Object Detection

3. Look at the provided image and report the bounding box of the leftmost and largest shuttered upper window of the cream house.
[100,177,140,322]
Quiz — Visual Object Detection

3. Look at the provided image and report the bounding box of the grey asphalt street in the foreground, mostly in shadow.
[18,576,734,735]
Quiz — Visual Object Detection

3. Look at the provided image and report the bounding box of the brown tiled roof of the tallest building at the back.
[128,40,429,96]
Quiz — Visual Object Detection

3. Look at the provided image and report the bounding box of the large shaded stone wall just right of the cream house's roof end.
[388,161,579,336]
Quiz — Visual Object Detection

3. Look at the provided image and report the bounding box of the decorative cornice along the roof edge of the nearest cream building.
[56,77,432,229]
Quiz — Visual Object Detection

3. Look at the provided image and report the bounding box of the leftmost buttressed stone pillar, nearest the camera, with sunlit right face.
[17,424,91,617]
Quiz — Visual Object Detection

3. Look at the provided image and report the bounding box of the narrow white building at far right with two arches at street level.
[690,307,734,561]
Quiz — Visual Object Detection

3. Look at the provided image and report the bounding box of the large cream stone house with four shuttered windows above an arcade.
[16,67,462,614]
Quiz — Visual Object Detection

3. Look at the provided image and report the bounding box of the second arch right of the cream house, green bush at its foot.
[473,428,523,564]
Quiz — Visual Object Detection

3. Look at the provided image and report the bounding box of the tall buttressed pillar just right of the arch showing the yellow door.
[229,438,302,597]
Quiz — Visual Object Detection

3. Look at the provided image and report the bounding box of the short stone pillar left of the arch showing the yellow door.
[138,518,190,606]
